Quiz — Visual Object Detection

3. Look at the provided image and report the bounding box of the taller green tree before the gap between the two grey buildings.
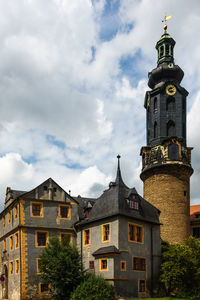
[40,237,83,300]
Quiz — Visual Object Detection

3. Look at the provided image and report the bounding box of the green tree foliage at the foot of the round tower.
[161,237,200,295]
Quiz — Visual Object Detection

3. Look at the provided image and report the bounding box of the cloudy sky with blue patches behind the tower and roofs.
[0,0,200,208]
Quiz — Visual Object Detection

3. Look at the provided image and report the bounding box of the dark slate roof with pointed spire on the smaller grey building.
[79,157,160,225]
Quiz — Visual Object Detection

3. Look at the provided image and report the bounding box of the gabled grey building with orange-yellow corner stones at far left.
[0,178,79,300]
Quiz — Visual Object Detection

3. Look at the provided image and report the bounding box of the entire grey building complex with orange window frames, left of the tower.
[0,159,161,300]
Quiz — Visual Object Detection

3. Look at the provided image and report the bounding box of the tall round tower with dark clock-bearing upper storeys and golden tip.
[140,25,193,243]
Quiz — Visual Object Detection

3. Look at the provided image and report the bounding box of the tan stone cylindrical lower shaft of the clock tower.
[141,164,191,243]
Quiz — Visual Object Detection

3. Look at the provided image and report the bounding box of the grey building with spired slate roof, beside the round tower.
[76,158,161,297]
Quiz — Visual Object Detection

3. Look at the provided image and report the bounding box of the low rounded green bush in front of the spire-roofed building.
[70,274,116,300]
